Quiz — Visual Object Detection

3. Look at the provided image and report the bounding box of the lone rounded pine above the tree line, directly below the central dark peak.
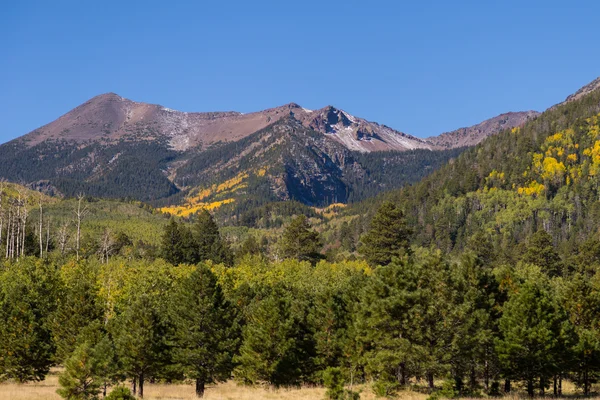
[280,215,324,265]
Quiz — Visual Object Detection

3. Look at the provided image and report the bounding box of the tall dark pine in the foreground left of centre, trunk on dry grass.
[170,265,239,397]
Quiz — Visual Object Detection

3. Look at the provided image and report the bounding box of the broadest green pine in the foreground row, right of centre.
[356,250,458,389]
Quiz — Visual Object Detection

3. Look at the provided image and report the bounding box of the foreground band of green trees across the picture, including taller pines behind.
[0,203,600,399]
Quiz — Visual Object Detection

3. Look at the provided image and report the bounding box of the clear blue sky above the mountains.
[0,0,600,144]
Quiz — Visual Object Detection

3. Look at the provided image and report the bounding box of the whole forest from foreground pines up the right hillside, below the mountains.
[0,86,600,399]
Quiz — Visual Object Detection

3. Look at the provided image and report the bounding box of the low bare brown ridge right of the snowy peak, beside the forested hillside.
[427,111,540,149]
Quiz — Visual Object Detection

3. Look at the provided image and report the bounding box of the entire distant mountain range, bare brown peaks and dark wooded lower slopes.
[0,93,538,215]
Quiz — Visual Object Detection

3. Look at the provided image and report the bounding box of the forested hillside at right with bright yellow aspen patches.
[330,85,600,260]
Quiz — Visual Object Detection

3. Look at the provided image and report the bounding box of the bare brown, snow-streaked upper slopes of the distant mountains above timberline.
[17,93,538,153]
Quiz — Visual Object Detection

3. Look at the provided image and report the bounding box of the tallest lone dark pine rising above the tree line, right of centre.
[359,202,411,266]
